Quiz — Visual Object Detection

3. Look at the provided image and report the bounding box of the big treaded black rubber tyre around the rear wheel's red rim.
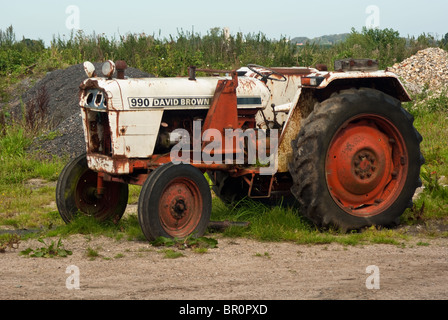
[289,88,424,231]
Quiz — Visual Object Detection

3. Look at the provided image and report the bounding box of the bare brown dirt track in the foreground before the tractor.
[0,228,448,300]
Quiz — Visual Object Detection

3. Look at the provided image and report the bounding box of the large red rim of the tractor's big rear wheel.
[325,114,408,217]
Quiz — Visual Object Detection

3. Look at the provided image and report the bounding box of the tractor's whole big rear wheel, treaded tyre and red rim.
[289,88,424,230]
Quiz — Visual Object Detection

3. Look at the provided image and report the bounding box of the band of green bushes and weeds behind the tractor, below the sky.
[0,27,448,87]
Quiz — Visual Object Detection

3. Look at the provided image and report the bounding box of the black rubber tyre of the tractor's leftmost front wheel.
[56,154,129,224]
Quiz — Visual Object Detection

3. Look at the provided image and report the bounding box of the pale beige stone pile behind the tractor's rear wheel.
[388,48,448,94]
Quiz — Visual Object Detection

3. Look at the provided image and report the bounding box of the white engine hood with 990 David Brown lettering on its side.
[80,77,271,111]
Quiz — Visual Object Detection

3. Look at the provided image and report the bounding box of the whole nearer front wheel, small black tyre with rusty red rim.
[138,163,212,241]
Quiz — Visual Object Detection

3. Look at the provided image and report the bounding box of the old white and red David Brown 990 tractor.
[56,59,424,240]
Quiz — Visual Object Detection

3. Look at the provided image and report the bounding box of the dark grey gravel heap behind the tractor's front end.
[26,63,153,158]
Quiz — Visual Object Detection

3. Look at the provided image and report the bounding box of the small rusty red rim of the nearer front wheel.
[159,177,203,237]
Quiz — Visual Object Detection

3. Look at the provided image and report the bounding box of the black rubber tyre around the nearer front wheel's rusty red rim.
[138,163,212,241]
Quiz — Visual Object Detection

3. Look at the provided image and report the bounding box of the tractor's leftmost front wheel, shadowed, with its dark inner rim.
[56,154,129,223]
